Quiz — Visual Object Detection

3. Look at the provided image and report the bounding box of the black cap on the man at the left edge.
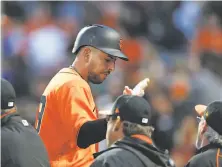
[1,78,16,110]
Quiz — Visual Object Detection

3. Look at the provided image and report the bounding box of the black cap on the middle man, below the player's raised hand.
[110,95,152,126]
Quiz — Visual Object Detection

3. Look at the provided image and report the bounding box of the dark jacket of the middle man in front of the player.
[91,137,174,167]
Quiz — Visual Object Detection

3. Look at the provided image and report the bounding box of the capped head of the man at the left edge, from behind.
[1,78,16,119]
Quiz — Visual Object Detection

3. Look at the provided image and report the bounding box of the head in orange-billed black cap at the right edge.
[195,101,222,149]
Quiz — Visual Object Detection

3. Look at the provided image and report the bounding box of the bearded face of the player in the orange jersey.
[88,50,116,84]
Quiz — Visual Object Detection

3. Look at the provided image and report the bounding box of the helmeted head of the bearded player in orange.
[72,24,128,84]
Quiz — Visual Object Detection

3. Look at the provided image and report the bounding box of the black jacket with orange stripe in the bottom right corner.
[185,144,222,167]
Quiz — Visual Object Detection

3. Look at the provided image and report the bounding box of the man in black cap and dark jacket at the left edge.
[1,79,49,167]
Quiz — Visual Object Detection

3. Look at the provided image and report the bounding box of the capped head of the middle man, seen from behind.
[106,95,154,146]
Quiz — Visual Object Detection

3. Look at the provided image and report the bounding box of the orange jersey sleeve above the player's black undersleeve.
[61,87,96,142]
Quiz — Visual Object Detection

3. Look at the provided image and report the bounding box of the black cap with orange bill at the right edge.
[195,101,222,135]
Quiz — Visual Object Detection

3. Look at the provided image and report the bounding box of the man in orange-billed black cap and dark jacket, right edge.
[186,101,222,167]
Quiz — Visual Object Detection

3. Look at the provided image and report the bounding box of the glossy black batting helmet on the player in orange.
[72,24,128,61]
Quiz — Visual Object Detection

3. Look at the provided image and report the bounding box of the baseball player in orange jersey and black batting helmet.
[35,24,132,167]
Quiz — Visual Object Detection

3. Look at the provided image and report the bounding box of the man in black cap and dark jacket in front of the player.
[91,95,173,167]
